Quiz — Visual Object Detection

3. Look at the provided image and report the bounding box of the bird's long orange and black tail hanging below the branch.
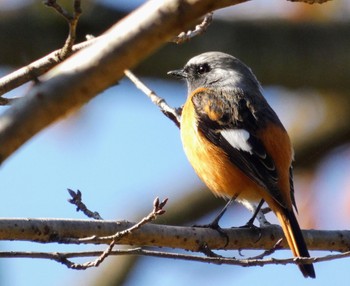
[275,209,316,278]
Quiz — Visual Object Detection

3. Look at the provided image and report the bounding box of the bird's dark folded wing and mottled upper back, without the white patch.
[192,89,284,205]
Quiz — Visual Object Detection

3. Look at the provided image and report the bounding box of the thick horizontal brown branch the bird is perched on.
[0,219,350,252]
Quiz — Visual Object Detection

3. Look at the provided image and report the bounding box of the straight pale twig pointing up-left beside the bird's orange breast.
[124,70,181,127]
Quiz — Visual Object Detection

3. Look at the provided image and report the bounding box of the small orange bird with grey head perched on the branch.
[168,52,315,278]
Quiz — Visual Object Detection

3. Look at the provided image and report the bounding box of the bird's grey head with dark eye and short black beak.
[168,52,260,93]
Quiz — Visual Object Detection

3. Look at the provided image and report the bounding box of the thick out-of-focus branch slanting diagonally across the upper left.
[0,0,244,165]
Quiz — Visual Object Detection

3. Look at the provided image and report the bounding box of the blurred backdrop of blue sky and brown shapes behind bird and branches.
[0,0,350,286]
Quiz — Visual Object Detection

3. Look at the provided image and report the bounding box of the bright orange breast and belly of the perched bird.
[181,100,265,202]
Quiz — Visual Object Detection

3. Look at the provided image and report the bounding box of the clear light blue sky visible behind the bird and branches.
[0,76,349,286]
